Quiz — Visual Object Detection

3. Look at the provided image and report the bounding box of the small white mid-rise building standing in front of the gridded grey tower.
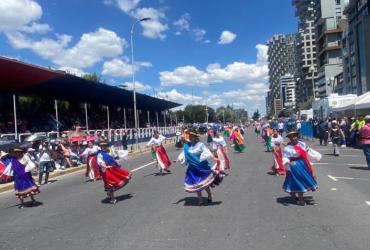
[280,74,296,109]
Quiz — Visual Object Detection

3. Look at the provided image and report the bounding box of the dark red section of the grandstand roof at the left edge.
[0,56,65,91]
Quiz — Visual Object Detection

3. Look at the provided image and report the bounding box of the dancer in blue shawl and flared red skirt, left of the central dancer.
[97,141,132,204]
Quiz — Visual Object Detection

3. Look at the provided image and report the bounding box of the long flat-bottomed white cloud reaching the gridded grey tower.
[159,45,268,86]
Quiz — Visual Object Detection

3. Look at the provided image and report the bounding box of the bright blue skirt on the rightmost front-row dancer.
[283,160,318,193]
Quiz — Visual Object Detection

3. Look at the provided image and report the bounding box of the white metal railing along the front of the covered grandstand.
[0,127,180,144]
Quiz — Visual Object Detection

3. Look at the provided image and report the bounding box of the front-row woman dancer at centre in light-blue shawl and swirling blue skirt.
[177,129,222,206]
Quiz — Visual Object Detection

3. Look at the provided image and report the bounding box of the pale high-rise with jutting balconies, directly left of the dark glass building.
[315,0,349,98]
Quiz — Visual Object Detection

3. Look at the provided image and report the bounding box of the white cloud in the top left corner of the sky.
[0,0,42,31]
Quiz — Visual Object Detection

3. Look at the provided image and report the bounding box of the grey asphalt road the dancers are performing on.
[0,131,370,250]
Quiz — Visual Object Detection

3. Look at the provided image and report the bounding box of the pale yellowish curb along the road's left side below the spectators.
[0,142,175,194]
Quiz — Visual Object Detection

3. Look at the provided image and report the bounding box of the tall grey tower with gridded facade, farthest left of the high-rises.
[267,34,296,115]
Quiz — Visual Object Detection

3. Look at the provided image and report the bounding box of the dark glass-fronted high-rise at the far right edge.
[337,0,370,95]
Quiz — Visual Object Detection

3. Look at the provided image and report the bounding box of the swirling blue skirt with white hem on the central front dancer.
[184,165,222,193]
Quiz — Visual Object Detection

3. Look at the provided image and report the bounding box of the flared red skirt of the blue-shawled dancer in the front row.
[102,167,132,192]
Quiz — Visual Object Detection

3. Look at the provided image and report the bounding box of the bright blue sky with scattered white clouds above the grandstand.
[0,0,297,112]
